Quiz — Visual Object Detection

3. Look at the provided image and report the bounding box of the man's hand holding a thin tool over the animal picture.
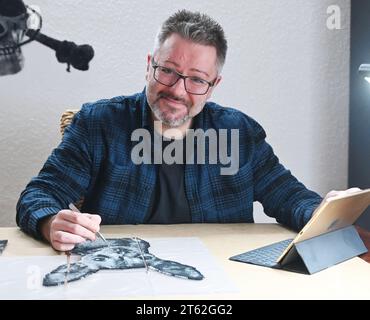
[40,210,101,251]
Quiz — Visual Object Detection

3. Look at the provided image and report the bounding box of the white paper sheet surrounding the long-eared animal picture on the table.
[0,237,237,299]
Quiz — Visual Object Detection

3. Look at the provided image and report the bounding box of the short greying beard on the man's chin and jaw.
[147,92,192,128]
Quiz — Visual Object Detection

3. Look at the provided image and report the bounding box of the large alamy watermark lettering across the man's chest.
[131,121,239,175]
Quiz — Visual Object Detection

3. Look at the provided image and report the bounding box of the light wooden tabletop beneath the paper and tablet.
[0,224,370,299]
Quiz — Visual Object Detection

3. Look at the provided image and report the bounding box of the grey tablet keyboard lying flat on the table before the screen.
[230,239,293,268]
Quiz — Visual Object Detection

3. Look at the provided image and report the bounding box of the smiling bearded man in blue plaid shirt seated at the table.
[17,10,370,260]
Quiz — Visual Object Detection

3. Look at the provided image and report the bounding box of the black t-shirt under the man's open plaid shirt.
[145,140,191,224]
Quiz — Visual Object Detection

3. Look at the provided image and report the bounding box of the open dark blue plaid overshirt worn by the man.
[17,89,322,238]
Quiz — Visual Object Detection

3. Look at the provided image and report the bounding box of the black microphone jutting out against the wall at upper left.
[26,29,94,72]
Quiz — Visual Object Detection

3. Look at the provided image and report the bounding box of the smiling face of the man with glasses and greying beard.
[146,34,221,128]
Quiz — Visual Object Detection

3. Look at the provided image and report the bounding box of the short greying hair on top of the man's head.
[154,10,227,72]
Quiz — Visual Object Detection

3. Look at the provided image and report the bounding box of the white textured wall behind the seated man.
[0,0,350,226]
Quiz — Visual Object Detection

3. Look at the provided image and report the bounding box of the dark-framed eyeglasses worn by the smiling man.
[152,59,217,95]
